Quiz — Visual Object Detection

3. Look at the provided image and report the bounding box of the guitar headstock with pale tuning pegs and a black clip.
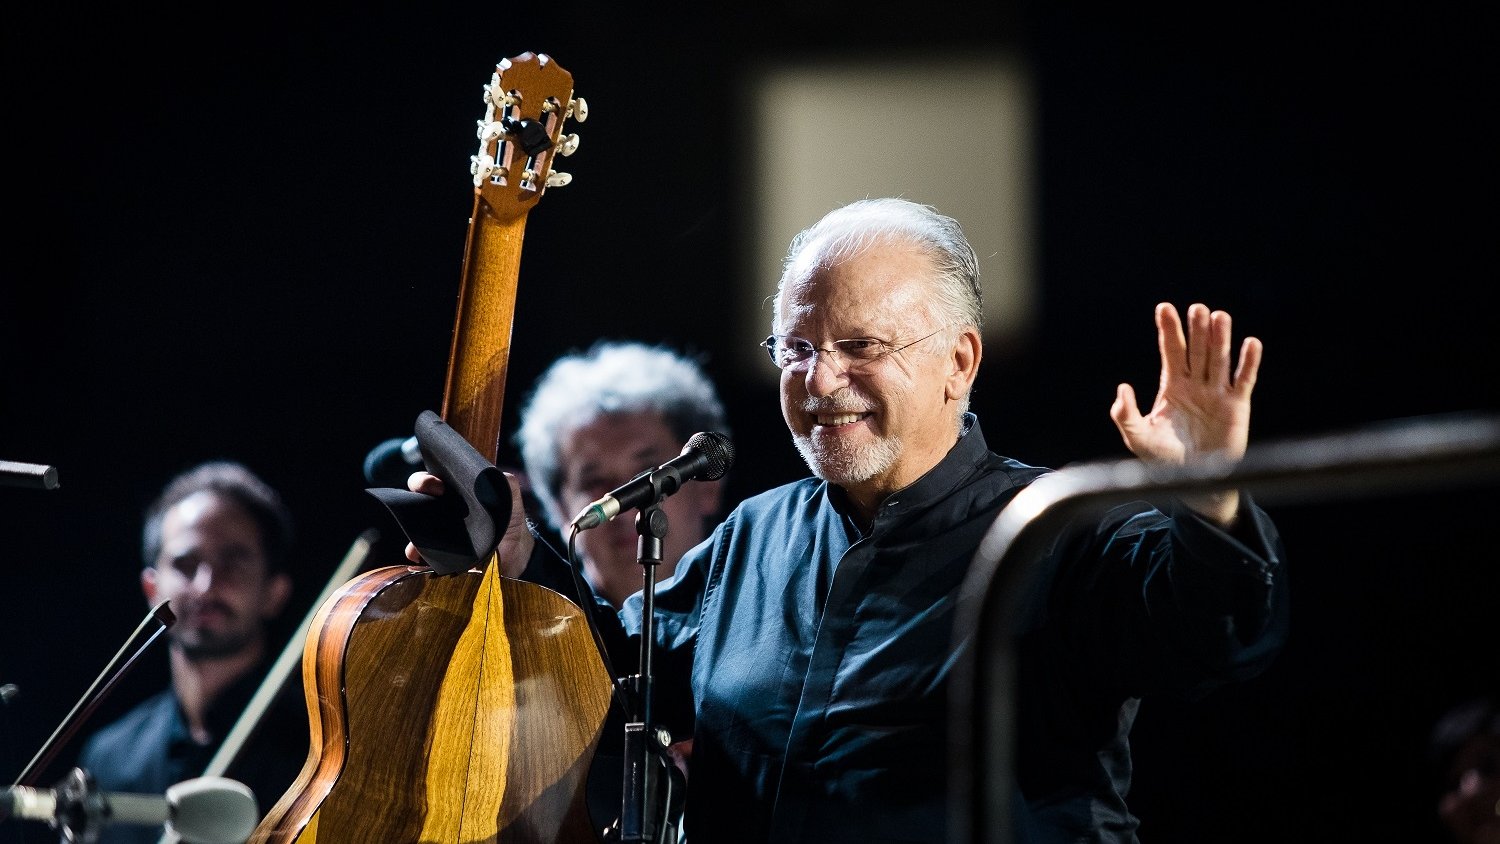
[470,52,588,217]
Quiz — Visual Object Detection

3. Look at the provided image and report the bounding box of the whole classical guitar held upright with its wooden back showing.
[251,52,614,844]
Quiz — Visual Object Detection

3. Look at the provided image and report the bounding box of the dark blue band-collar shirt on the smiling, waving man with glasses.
[620,414,1286,844]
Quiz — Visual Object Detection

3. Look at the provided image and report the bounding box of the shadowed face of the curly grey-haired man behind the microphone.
[557,412,720,606]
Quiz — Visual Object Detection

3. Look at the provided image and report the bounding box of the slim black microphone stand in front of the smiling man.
[618,498,686,844]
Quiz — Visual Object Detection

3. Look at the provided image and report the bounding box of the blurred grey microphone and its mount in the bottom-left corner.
[0,768,260,844]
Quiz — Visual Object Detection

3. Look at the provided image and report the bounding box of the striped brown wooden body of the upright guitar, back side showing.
[251,565,611,844]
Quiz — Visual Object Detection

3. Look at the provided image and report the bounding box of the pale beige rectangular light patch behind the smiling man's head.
[740,54,1034,375]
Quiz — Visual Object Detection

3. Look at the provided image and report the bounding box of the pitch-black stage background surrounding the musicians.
[0,6,1500,844]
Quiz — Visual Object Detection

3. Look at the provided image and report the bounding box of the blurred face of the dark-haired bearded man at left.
[141,492,291,660]
